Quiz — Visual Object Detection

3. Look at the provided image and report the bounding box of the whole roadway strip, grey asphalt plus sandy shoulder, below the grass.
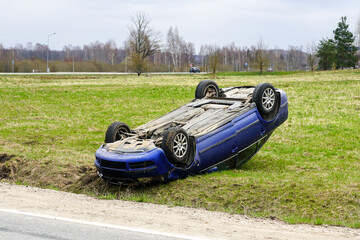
[0,182,360,240]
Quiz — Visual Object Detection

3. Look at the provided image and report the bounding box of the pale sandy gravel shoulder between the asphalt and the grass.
[0,183,360,240]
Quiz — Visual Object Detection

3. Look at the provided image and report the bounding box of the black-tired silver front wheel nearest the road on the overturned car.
[161,127,192,167]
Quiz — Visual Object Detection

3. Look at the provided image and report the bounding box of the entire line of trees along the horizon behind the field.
[0,12,360,75]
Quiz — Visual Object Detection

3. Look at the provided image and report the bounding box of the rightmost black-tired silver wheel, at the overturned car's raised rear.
[252,83,280,121]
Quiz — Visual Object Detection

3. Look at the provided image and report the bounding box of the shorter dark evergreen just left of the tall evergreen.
[317,39,336,70]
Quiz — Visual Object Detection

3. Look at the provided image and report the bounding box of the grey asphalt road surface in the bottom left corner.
[0,211,184,240]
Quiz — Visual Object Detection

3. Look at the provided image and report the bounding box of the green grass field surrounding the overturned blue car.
[0,71,360,227]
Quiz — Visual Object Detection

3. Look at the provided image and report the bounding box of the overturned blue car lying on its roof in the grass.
[95,80,288,183]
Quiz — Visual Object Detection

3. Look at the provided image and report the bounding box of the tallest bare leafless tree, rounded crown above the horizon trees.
[129,12,160,76]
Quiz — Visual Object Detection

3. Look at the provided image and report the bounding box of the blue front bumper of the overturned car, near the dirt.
[95,146,175,181]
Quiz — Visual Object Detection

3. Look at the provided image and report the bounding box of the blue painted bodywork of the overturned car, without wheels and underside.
[95,83,288,183]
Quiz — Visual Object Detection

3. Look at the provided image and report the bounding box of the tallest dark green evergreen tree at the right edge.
[334,17,358,69]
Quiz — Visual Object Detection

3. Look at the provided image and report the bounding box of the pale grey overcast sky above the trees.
[0,0,360,51]
